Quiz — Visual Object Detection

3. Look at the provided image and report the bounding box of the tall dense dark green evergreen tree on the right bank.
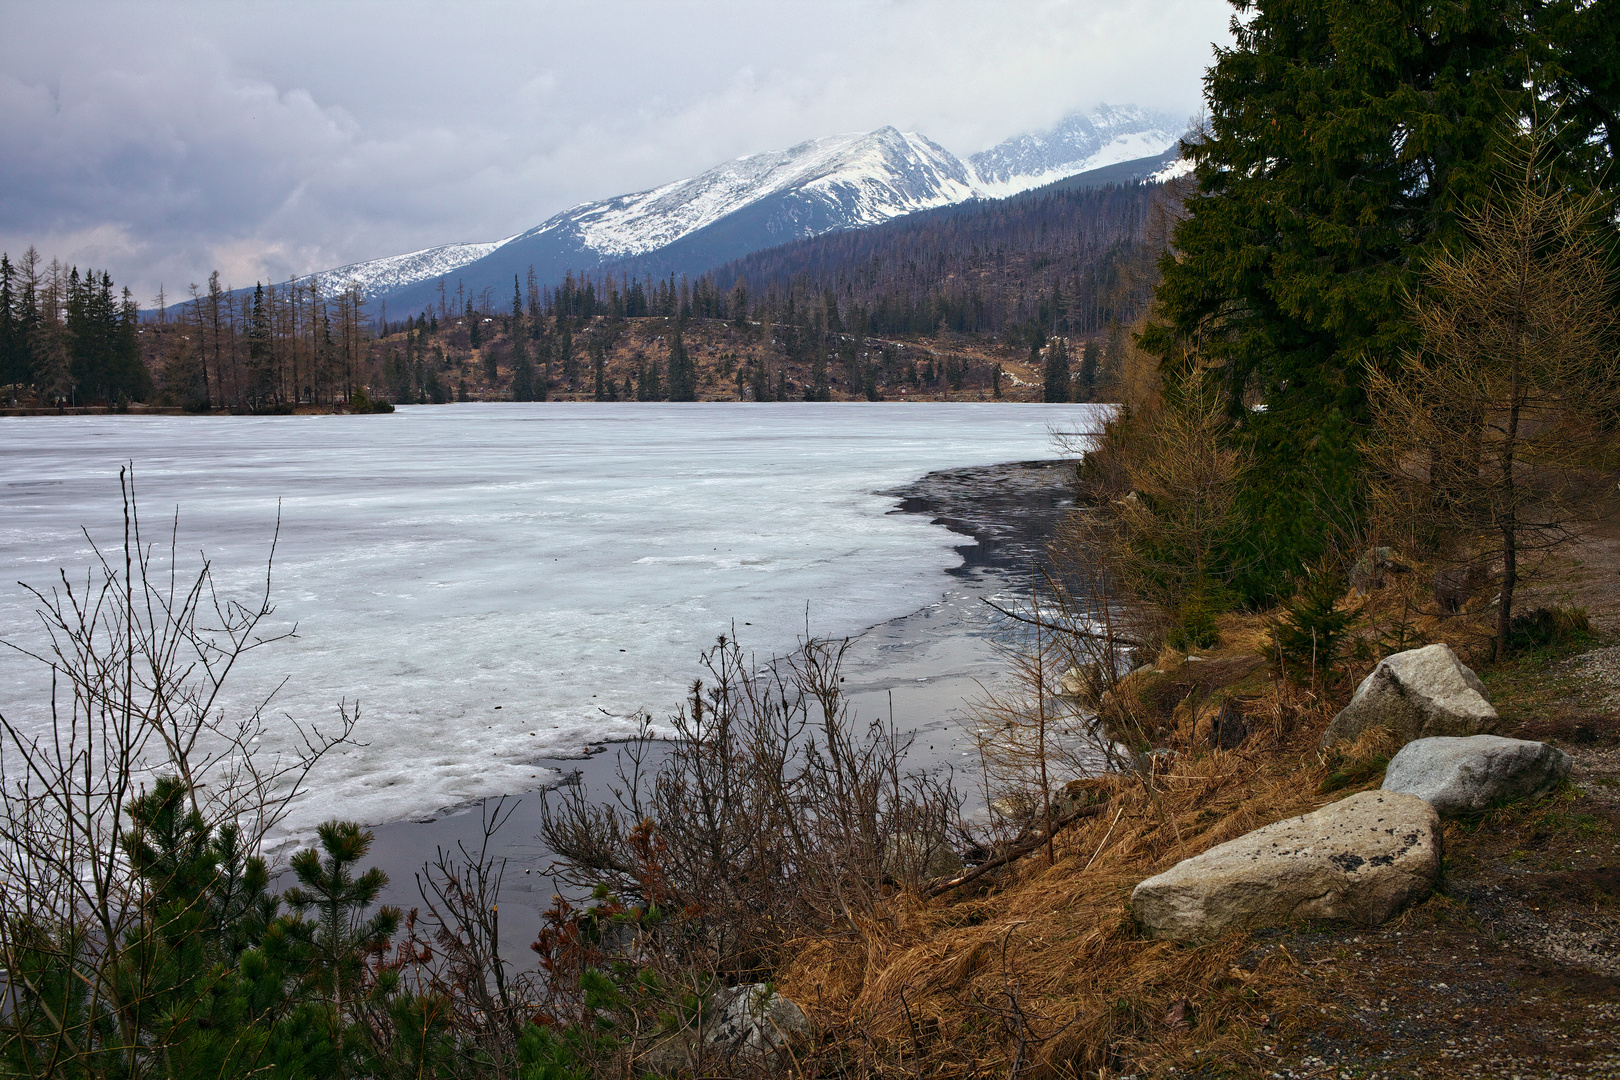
[1144,0,1620,597]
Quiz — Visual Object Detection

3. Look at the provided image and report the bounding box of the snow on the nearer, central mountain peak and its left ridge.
[517,128,975,261]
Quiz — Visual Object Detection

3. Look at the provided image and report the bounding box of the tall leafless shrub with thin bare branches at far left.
[0,470,360,1075]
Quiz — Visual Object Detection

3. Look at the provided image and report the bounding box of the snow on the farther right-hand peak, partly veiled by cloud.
[967,105,1186,198]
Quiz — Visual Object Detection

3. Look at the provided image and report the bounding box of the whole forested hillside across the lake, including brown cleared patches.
[0,175,1178,413]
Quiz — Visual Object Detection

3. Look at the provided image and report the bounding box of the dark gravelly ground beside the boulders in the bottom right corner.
[1224,550,1620,1080]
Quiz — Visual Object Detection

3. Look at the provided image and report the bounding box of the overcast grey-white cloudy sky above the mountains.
[0,0,1231,306]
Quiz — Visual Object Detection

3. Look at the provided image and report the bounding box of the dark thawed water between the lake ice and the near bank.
[366,458,1074,967]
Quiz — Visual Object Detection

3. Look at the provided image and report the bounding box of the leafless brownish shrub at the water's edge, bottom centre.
[541,636,959,980]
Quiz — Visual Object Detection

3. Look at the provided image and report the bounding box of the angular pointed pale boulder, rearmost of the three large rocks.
[1322,644,1497,750]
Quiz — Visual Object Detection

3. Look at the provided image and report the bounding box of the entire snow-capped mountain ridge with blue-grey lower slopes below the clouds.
[301,105,1181,313]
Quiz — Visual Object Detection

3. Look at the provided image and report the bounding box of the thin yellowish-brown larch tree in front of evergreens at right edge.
[1369,139,1620,659]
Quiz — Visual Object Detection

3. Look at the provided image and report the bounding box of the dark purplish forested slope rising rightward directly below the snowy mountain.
[400,185,1175,344]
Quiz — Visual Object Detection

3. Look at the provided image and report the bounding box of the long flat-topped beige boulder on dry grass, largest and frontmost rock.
[1131,792,1440,939]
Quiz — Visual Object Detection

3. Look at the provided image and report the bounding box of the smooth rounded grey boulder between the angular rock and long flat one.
[1383,735,1570,816]
